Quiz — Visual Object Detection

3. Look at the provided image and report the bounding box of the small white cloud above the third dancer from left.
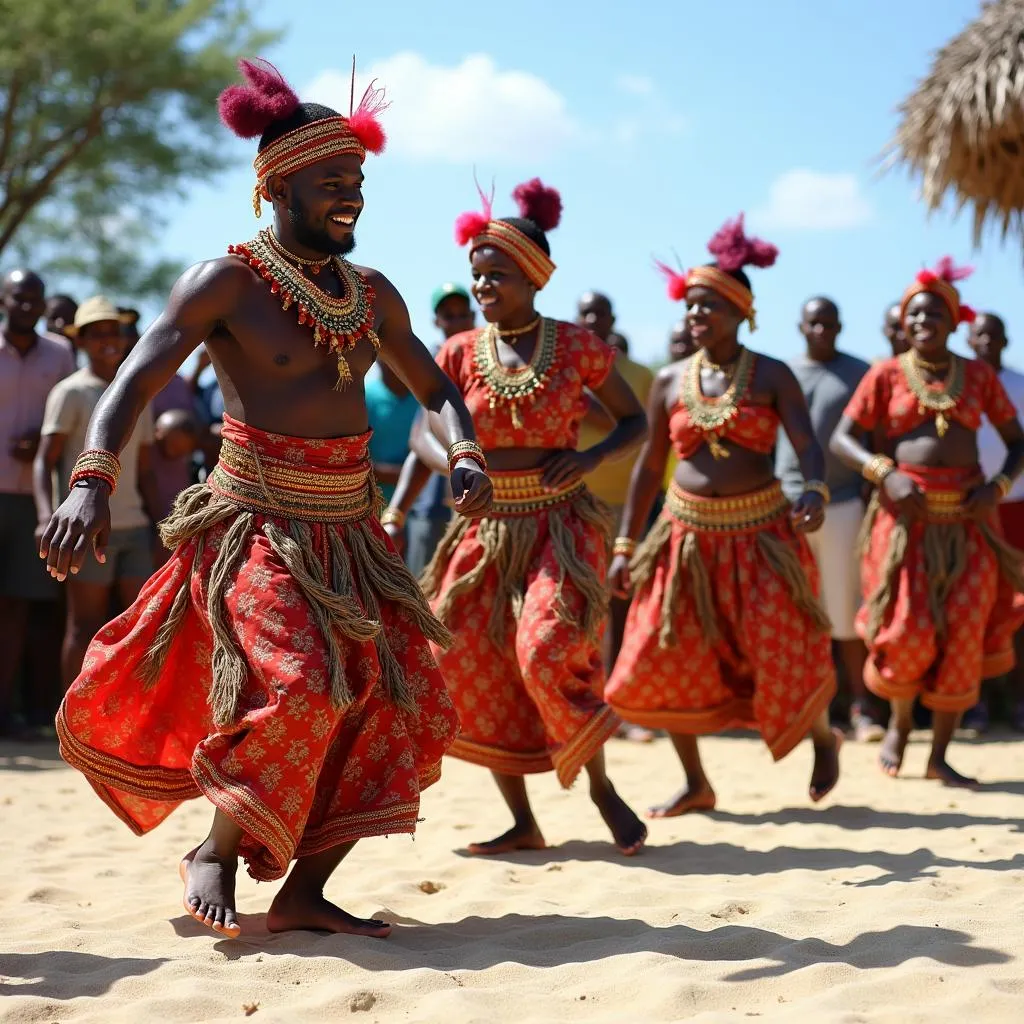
[751,168,874,231]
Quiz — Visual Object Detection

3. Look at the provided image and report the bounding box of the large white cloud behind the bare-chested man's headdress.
[301,52,582,165]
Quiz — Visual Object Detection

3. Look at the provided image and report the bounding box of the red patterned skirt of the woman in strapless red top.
[604,483,836,760]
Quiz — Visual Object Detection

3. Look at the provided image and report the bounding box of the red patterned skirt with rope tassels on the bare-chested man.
[57,417,458,880]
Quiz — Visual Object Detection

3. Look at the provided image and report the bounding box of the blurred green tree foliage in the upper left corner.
[0,0,276,301]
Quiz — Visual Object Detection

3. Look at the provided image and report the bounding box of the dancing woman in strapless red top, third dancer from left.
[605,216,840,817]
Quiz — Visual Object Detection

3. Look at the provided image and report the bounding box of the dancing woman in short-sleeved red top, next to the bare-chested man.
[382,178,646,855]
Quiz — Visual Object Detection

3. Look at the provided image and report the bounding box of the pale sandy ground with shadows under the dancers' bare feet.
[0,737,1024,1024]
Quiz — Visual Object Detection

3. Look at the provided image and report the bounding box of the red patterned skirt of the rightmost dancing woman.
[857,466,1024,712]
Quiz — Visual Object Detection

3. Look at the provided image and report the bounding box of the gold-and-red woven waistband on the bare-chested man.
[207,438,380,522]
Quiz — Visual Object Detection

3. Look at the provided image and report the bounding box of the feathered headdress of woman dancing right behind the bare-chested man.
[455,178,562,288]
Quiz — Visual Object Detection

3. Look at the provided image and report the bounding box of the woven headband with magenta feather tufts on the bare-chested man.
[217,57,389,217]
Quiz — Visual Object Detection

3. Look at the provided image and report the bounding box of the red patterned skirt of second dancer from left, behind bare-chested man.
[423,473,617,786]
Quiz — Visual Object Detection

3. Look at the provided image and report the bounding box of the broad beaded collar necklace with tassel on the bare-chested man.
[227,227,381,391]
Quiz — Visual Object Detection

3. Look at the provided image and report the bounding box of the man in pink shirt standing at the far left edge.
[0,270,75,735]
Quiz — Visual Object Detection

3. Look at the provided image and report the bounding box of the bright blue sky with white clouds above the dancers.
[153,0,1024,365]
